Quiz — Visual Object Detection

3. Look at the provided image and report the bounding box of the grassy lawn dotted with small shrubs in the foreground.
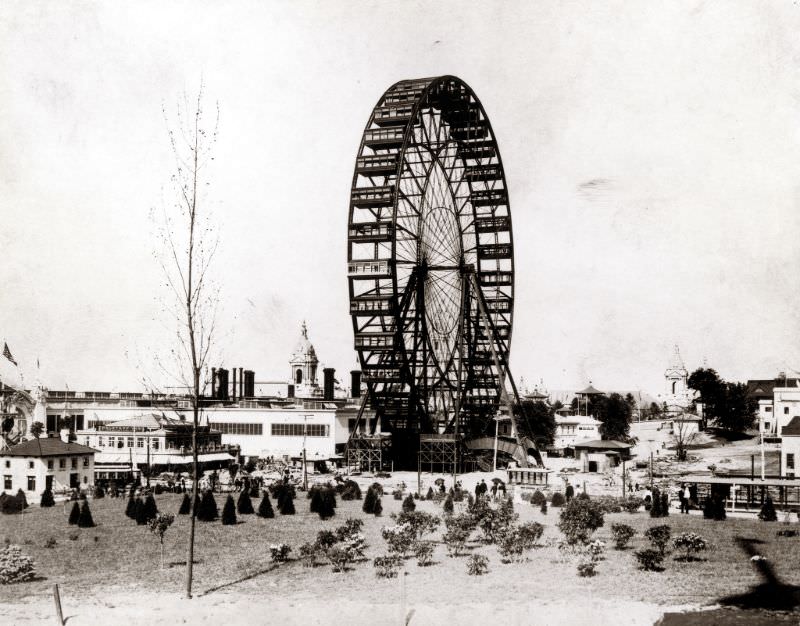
[0,494,800,605]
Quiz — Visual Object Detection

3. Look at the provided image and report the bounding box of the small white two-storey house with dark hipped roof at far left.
[0,437,95,501]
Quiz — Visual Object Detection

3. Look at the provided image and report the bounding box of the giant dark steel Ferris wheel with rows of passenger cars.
[348,76,516,450]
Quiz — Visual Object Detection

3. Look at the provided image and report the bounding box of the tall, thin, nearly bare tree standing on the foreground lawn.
[157,83,219,598]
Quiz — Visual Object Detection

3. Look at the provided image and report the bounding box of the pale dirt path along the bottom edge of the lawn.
[2,589,681,626]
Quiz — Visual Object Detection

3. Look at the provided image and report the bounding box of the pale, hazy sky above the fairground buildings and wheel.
[0,0,800,393]
